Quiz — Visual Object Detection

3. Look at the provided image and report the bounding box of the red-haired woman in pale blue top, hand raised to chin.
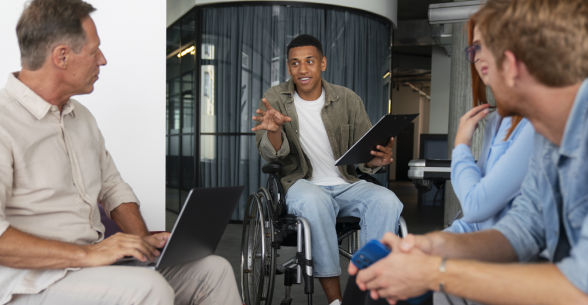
[446,19,535,233]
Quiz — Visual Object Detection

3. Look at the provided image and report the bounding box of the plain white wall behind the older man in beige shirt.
[0,0,166,231]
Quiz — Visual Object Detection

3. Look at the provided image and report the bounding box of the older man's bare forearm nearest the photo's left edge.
[0,227,87,269]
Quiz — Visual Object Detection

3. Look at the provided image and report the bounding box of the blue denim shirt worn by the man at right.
[494,79,588,293]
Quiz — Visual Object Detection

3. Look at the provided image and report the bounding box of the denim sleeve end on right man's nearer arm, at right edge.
[556,205,588,294]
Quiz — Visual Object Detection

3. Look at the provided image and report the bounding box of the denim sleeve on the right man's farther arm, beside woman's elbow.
[493,152,545,262]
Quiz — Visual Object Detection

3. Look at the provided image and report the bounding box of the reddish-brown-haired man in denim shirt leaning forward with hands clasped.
[349,0,588,305]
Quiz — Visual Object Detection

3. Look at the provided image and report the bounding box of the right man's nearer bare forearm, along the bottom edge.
[429,258,588,305]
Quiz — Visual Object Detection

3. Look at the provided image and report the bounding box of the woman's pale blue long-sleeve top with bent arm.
[446,112,535,233]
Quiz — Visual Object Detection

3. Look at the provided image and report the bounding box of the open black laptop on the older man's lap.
[112,186,245,270]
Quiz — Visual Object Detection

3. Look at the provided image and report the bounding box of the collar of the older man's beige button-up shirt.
[6,72,75,120]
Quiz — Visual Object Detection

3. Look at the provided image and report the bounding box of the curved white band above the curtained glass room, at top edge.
[167,0,398,26]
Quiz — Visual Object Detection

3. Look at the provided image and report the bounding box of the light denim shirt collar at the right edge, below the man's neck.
[559,78,588,157]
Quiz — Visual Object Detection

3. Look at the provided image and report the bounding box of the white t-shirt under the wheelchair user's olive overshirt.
[294,89,348,185]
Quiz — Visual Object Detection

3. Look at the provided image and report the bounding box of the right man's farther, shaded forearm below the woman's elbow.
[426,229,517,263]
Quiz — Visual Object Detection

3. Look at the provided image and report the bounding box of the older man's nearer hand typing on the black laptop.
[80,233,165,267]
